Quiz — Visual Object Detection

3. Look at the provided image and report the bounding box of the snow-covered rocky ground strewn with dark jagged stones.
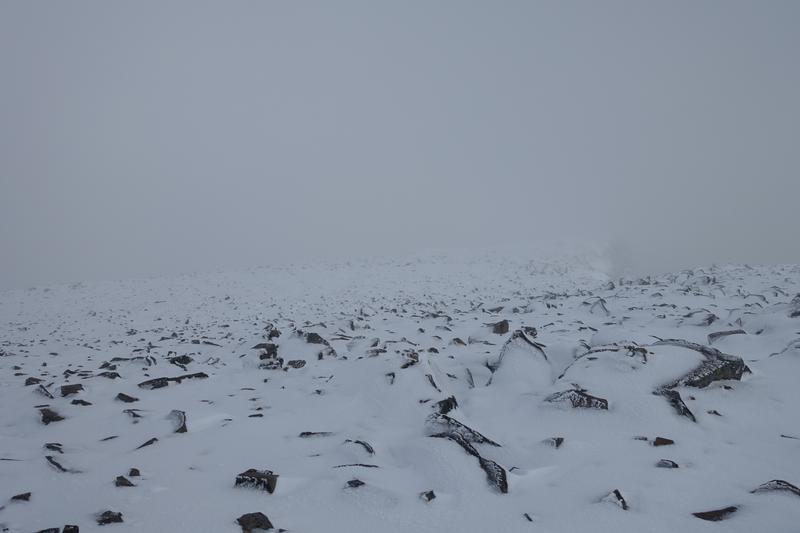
[0,253,800,533]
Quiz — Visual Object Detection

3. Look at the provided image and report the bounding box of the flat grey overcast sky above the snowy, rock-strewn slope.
[0,0,800,287]
